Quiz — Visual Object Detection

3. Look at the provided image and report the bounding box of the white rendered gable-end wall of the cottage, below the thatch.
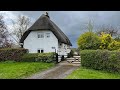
[24,30,58,53]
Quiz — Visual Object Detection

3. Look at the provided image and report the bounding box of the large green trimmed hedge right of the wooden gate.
[80,50,120,72]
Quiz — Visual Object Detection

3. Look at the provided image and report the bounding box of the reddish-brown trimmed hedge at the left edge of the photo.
[0,48,28,61]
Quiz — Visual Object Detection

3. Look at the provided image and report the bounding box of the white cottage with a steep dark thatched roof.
[20,14,72,56]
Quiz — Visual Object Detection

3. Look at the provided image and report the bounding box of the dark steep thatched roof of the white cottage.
[20,14,72,46]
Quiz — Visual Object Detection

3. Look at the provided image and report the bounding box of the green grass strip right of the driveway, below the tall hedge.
[66,67,120,79]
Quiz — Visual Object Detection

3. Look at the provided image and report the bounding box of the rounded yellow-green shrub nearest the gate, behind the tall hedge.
[77,32,100,50]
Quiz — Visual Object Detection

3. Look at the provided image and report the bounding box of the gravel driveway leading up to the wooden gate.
[26,62,79,79]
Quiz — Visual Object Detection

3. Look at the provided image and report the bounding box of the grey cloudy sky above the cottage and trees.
[0,11,120,47]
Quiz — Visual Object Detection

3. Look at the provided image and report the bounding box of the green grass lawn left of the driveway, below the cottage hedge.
[0,62,54,79]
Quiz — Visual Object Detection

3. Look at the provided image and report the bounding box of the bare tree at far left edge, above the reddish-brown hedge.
[0,15,10,48]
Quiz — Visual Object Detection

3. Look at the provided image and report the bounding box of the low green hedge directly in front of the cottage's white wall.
[21,53,55,62]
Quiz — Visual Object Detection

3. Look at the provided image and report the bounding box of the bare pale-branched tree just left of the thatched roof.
[12,15,30,44]
